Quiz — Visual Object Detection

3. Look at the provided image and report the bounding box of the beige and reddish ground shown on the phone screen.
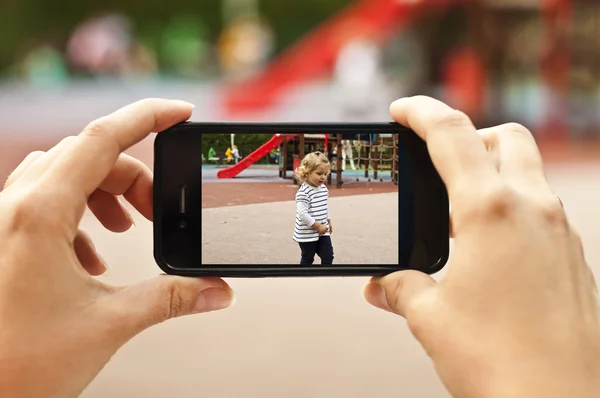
[202,166,398,264]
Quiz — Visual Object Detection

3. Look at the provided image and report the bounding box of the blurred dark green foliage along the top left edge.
[0,0,351,74]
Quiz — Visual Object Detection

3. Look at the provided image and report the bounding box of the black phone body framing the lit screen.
[153,122,449,277]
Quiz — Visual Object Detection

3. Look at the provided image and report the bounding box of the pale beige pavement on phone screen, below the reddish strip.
[202,193,398,264]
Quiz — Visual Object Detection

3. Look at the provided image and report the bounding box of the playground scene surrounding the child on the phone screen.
[202,134,398,264]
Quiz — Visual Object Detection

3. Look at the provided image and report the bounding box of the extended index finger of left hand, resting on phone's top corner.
[34,99,193,230]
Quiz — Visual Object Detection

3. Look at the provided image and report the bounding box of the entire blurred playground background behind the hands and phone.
[0,0,600,397]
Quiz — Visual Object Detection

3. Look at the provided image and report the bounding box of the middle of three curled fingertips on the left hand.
[88,189,133,232]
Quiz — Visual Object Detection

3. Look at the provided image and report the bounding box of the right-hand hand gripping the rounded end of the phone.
[364,97,600,398]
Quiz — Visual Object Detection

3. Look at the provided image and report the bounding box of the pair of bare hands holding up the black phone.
[0,97,600,398]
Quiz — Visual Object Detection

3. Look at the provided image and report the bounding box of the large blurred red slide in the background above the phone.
[223,0,446,117]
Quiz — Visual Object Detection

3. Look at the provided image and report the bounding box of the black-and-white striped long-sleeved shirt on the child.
[294,183,329,243]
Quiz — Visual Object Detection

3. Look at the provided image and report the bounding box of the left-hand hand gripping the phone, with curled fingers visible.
[0,100,233,397]
